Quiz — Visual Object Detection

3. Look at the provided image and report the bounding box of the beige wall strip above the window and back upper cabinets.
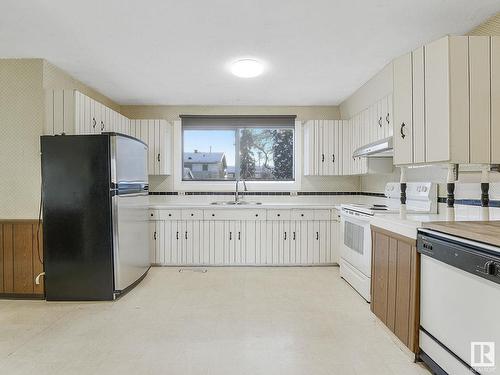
[121,106,340,120]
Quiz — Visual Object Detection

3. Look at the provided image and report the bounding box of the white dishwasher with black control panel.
[417,229,500,375]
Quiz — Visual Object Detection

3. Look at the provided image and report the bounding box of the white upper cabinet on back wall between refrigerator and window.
[130,120,172,175]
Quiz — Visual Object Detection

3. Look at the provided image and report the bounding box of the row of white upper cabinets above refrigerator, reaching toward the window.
[44,90,172,175]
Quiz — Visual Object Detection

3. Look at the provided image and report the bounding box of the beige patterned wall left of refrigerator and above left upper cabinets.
[0,59,120,219]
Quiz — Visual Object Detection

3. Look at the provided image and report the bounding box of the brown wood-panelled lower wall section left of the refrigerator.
[0,220,44,298]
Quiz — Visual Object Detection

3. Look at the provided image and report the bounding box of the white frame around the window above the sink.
[173,116,302,192]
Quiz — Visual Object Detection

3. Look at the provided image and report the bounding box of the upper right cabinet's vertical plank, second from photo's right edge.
[469,36,490,164]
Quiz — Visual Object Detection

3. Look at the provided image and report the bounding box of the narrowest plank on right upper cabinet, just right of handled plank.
[412,47,425,163]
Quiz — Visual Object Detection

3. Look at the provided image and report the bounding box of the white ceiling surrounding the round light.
[0,0,500,105]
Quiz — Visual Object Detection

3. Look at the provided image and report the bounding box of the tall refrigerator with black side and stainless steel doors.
[40,133,150,301]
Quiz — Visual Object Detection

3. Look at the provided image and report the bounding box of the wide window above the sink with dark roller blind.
[182,116,295,181]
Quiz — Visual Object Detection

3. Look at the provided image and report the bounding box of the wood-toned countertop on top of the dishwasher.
[423,221,500,247]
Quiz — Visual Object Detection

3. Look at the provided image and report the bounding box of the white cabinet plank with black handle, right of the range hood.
[393,53,413,165]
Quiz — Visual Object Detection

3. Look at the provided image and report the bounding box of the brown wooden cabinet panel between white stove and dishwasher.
[371,226,420,353]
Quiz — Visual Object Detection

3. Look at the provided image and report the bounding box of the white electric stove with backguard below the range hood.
[339,182,437,302]
